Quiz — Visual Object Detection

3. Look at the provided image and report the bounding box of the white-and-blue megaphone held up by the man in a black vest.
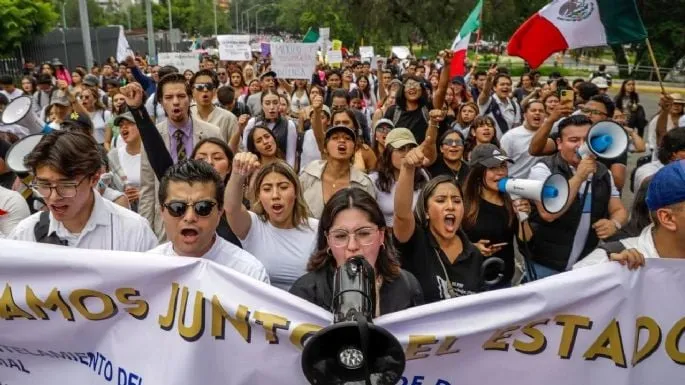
[578,120,630,159]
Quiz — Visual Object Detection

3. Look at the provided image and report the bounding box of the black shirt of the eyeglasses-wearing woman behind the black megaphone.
[290,265,424,315]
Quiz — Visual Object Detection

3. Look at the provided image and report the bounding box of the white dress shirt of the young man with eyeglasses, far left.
[8,190,157,251]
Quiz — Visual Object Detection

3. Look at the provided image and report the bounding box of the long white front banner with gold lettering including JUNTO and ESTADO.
[0,241,685,385]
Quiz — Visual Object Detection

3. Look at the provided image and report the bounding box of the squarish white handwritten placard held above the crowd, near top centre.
[271,43,318,80]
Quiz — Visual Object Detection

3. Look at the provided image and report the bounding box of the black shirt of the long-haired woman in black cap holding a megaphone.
[464,198,518,282]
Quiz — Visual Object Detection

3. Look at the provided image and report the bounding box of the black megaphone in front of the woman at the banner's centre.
[302,257,405,385]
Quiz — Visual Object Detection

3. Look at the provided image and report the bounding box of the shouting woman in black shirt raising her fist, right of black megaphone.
[392,146,484,303]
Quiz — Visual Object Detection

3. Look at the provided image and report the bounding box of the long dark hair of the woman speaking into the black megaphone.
[307,187,400,282]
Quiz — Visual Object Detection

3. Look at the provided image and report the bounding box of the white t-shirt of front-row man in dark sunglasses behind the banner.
[150,235,269,283]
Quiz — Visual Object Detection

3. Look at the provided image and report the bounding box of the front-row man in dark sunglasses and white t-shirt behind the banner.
[150,160,269,283]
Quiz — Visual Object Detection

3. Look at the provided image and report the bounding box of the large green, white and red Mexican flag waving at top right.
[507,0,647,68]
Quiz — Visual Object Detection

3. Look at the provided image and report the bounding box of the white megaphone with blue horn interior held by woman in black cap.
[497,174,568,222]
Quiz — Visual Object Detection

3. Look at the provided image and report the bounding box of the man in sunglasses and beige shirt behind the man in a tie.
[190,70,238,143]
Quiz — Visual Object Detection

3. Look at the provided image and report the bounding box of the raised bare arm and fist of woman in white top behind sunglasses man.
[224,152,260,239]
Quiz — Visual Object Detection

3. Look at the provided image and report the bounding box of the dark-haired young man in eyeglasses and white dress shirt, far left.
[8,131,157,251]
